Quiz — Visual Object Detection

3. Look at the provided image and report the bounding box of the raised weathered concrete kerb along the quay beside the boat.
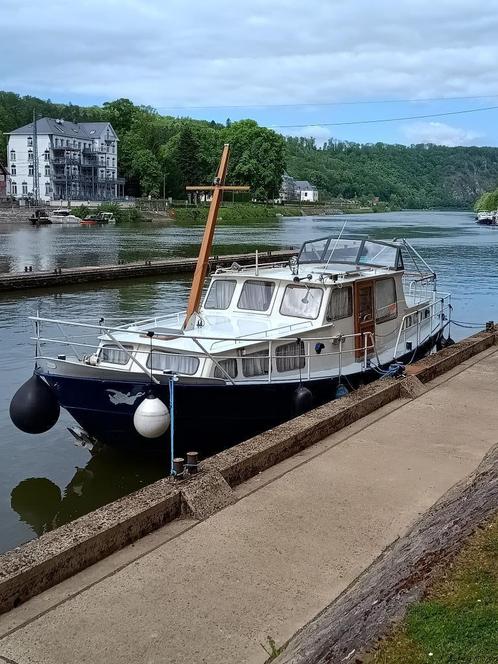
[0,332,497,613]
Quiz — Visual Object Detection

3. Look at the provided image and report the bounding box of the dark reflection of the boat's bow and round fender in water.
[11,447,169,536]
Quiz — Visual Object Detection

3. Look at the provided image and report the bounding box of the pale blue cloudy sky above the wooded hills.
[0,0,498,146]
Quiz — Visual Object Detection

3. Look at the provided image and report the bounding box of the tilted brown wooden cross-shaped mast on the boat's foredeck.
[183,143,249,328]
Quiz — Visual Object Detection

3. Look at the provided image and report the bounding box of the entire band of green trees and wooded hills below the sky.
[0,92,498,208]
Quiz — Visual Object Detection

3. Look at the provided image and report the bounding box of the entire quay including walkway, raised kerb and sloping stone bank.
[0,331,498,664]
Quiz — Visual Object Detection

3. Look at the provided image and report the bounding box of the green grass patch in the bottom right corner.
[367,518,498,664]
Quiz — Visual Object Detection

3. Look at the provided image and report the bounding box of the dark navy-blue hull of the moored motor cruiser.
[39,332,442,457]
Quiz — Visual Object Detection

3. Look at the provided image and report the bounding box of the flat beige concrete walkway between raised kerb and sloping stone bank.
[0,348,498,664]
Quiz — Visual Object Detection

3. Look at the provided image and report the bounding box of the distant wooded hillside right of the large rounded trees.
[286,138,498,208]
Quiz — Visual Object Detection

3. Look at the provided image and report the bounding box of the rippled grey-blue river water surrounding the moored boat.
[0,211,498,551]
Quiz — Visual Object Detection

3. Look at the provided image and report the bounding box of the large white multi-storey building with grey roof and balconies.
[7,118,124,201]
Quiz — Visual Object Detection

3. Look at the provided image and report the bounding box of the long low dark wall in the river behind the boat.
[0,249,297,292]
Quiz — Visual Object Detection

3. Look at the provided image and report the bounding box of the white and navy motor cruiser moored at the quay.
[11,146,451,456]
